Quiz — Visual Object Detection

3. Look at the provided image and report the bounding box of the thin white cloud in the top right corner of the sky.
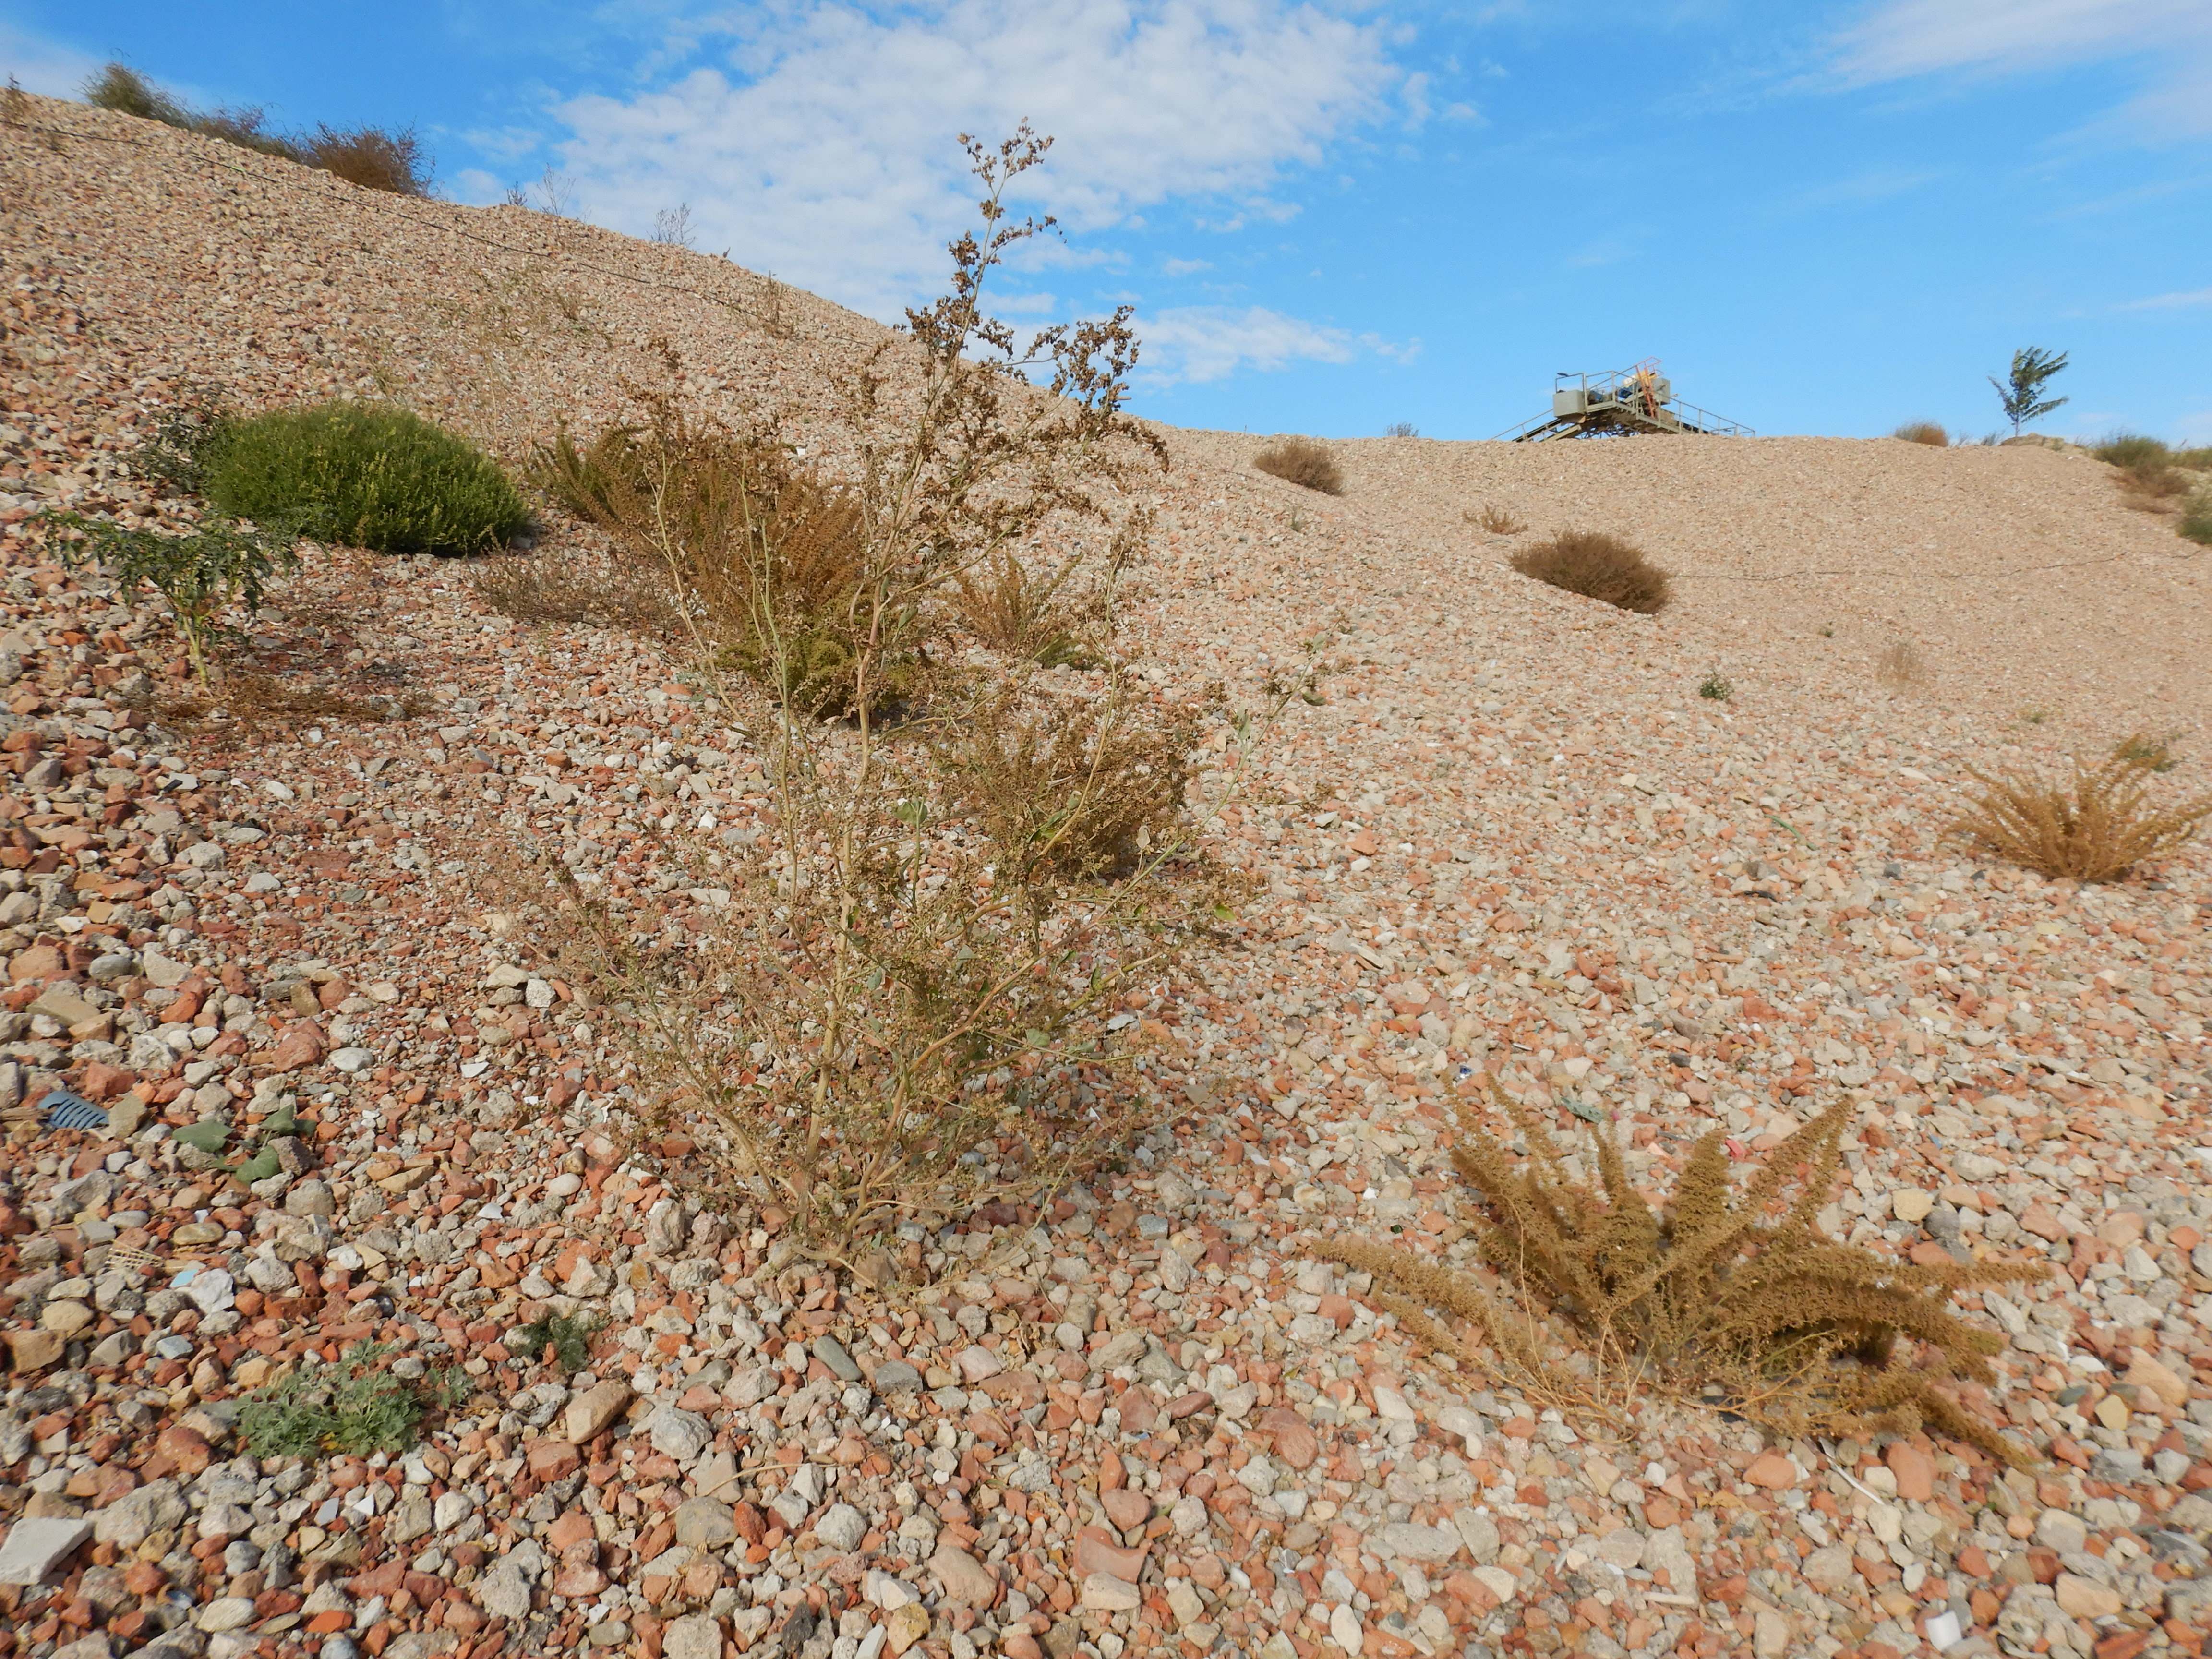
[1836,0,2212,135]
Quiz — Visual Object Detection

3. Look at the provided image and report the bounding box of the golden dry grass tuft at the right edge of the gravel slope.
[1951,736,2212,880]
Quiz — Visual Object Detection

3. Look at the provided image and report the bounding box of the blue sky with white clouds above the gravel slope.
[0,0,2212,443]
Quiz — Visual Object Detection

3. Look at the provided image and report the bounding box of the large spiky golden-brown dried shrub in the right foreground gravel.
[1310,1091,2046,1460]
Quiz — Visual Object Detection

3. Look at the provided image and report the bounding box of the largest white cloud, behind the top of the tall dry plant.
[544,0,1402,316]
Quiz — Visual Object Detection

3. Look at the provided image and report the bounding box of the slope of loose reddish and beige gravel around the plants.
[0,99,2212,1659]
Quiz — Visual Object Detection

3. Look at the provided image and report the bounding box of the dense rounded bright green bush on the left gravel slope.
[204,403,529,553]
